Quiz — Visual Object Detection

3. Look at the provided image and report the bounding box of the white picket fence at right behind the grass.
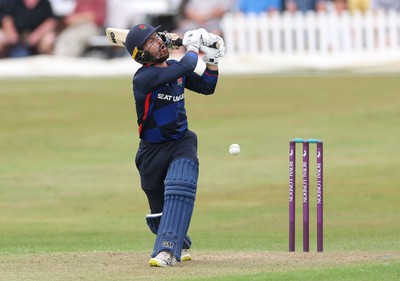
[222,11,400,56]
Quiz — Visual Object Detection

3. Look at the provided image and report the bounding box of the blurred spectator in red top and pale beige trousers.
[54,0,107,57]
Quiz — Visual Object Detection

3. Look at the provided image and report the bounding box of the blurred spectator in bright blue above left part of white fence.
[238,0,283,14]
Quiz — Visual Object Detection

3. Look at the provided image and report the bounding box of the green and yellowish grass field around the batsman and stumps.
[0,75,400,280]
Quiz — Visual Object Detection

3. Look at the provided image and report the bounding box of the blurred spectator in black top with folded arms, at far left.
[0,0,57,57]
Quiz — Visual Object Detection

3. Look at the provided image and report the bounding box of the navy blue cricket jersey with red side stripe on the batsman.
[133,52,218,143]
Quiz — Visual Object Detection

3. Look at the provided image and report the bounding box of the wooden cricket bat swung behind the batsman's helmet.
[106,27,219,50]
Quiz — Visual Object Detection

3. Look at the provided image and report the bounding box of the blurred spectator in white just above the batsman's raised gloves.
[176,0,235,35]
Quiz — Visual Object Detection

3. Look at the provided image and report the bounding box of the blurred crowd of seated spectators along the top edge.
[0,0,400,58]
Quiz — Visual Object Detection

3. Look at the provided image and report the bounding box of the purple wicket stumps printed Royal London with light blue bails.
[289,138,324,252]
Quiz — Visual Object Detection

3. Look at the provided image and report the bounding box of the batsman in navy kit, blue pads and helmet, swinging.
[125,24,225,267]
